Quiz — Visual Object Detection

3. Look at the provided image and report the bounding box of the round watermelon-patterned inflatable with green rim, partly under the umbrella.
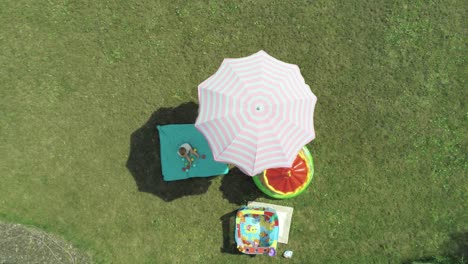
[253,146,314,199]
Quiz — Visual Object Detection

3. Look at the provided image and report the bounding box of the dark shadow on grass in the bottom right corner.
[403,232,468,264]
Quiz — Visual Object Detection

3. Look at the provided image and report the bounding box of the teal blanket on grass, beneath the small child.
[157,124,229,181]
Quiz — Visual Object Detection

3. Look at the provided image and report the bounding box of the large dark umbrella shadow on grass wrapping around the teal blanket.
[126,102,213,202]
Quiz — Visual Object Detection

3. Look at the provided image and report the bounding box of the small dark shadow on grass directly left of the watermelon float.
[219,168,266,205]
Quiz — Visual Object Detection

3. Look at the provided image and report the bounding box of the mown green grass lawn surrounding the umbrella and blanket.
[0,0,468,263]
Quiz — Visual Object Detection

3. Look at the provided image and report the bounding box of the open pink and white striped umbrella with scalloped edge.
[195,50,317,176]
